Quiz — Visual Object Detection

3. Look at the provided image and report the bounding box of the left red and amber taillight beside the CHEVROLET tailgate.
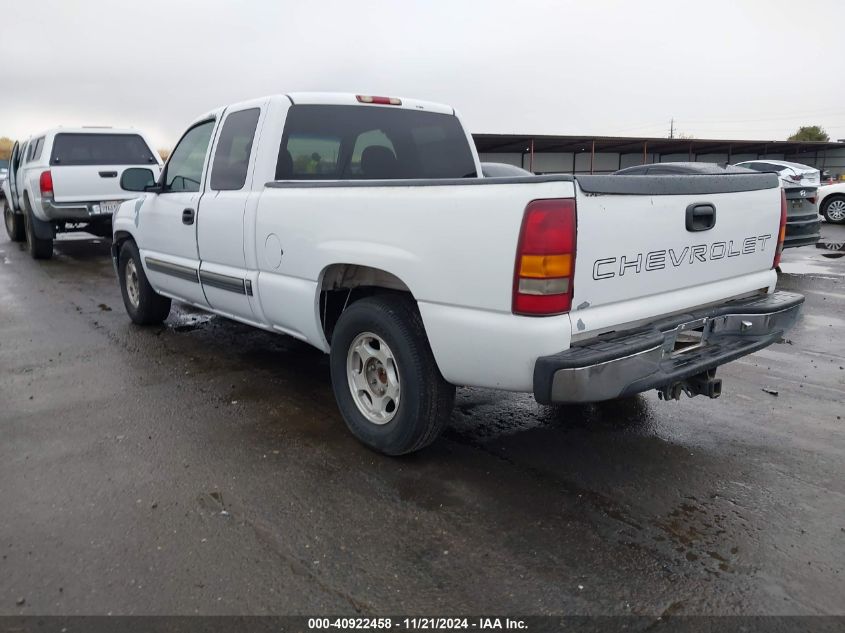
[513,198,576,316]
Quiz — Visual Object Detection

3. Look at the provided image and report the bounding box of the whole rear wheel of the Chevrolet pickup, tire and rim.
[330,295,455,455]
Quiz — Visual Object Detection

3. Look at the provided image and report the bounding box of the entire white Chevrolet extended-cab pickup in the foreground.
[112,93,803,455]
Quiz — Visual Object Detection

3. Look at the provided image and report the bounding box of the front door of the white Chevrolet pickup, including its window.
[136,119,215,306]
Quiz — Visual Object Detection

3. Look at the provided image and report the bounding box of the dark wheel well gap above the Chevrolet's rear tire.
[320,264,413,342]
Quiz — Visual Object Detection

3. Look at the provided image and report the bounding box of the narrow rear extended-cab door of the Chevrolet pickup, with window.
[197,102,264,320]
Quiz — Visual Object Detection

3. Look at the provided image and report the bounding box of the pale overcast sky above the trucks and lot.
[0,0,845,147]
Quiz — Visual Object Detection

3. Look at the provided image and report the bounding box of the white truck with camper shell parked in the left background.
[3,127,161,259]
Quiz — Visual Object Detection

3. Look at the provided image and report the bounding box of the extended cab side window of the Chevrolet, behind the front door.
[210,108,261,191]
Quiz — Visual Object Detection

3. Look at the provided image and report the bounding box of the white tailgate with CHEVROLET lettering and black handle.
[571,174,781,335]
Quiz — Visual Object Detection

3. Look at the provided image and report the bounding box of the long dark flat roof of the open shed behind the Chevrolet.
[472,134,845,155]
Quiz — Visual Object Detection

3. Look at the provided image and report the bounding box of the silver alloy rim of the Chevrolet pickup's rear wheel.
[346,332,401,425]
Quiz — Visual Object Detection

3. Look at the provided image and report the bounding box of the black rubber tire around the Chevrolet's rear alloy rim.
[330,295,455,455]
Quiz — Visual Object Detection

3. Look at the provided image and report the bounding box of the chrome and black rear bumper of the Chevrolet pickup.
[534,292,804,404]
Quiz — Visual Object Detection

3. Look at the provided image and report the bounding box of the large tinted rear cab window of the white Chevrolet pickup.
[276,104,476,180]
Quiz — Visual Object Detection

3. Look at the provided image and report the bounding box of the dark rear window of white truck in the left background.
[50,132,158,166]
